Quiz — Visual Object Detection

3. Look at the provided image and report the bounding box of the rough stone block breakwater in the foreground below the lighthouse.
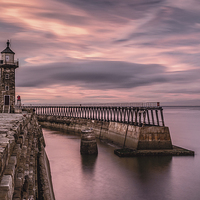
[0,113,55,200]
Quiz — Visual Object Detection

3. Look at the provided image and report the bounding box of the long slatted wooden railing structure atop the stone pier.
[22,102,165,126]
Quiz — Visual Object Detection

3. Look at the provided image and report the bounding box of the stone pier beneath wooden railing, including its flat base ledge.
[37,115,194,156]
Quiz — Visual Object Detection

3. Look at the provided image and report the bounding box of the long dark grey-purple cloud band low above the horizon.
[17,61,200,90]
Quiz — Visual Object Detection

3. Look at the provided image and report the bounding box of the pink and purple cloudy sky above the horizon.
[0,0,200,105]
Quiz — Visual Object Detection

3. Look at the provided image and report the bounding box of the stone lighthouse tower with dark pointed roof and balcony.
[0,40,19,113]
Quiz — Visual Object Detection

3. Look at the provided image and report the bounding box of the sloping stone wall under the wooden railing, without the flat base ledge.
[37,115,172,150]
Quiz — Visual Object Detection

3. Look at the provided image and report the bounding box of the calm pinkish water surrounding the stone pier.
[43,107,200,200]
